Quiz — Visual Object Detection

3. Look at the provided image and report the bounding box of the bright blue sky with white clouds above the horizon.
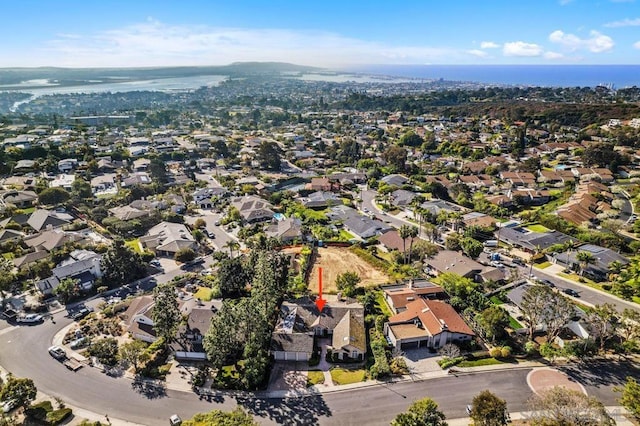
[0,0,640,68]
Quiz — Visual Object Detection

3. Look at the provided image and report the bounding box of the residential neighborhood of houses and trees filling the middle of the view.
[0,66,640,423]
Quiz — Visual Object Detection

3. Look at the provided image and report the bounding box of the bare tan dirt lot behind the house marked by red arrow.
[309,247,389,293]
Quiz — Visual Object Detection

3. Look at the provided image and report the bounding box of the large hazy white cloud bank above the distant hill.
[21,20,469,67]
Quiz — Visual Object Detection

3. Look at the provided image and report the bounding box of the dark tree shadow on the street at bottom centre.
[236,395,332,425]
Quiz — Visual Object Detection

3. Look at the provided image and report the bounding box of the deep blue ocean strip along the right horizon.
[342,65,640,89]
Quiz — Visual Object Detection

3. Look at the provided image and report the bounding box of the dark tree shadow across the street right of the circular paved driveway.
[557,359,640,388]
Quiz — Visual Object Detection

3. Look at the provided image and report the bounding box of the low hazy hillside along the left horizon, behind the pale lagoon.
[0,62,321,86]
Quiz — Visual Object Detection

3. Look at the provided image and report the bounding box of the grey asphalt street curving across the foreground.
[0,312,635,425]
